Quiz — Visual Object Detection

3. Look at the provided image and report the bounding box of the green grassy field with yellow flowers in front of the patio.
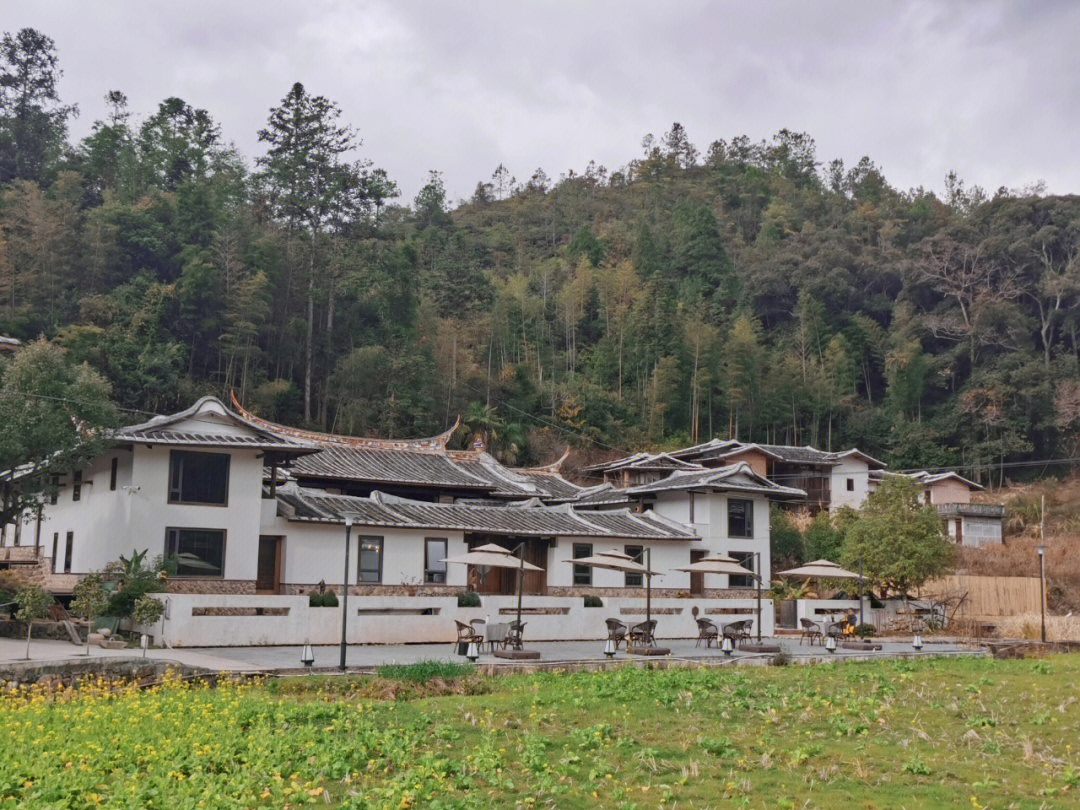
[0,654,1080,810]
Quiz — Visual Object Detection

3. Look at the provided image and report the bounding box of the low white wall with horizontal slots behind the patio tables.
[154,594,773,647]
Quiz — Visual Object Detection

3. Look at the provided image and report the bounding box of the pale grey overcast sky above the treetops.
[8,0,1080,201]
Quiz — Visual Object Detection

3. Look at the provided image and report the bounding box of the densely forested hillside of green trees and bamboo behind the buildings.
[0,30,1080,481]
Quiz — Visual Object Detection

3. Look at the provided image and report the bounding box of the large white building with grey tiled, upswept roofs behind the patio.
[0,397,805,644]
